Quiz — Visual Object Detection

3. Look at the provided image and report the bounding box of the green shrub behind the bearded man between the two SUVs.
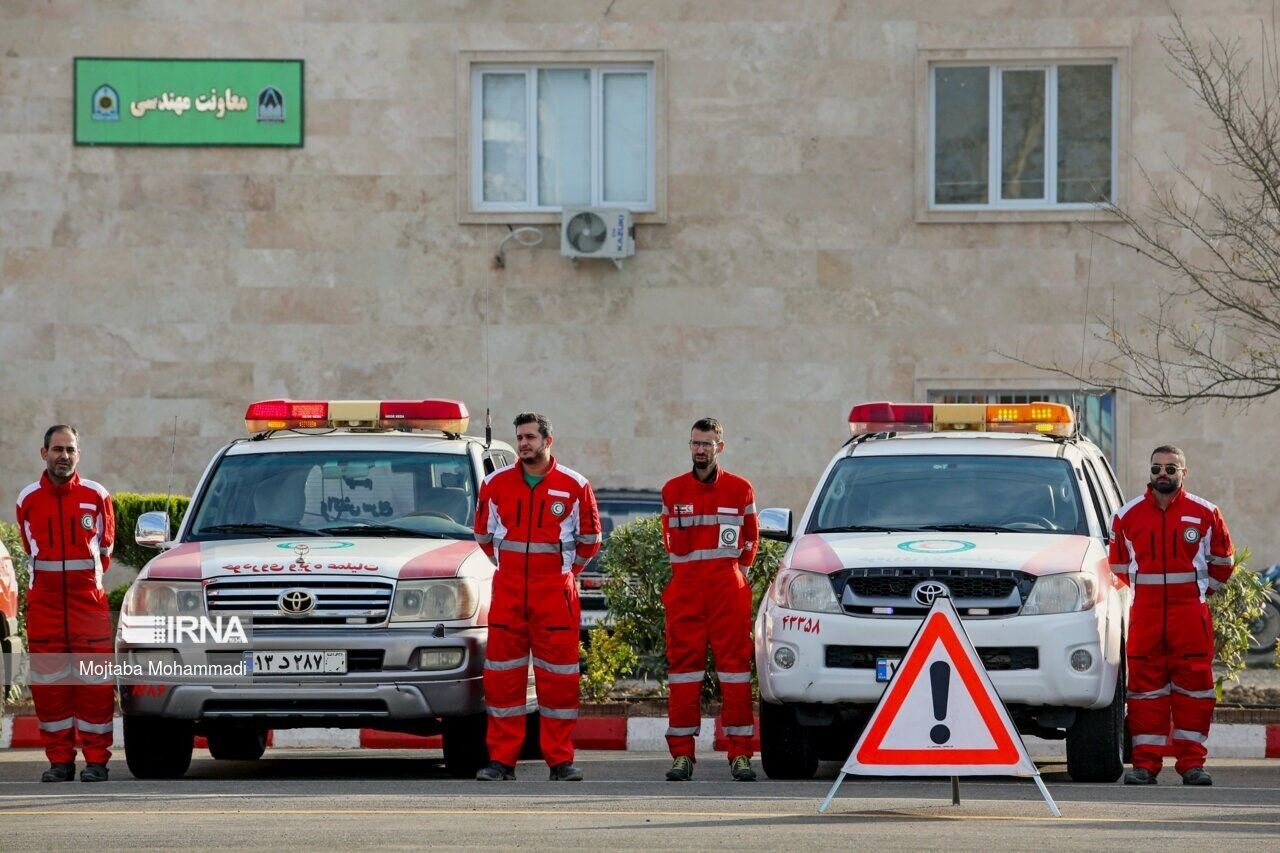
[593,519,786,689]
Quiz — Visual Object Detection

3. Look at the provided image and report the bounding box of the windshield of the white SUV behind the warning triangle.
[809,456,1088,535]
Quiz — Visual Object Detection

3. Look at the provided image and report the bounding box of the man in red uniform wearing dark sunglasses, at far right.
[1110,444,1234,785]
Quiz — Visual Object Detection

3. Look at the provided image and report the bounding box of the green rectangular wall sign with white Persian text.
[74,56,303,147]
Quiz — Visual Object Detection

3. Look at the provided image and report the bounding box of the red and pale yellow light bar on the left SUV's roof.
[244,400,471,434]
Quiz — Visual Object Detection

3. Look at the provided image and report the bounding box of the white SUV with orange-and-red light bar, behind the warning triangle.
[755,403,1129,781]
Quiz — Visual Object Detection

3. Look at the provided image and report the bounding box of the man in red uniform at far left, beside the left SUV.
[18,424,115,783]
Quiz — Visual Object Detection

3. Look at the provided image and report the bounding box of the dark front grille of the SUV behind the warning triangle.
[831,566,1036,617]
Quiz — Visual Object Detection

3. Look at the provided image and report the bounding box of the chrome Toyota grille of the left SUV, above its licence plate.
[205,578,394,630]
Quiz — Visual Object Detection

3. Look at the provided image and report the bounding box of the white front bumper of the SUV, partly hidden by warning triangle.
[755,601,1119,708]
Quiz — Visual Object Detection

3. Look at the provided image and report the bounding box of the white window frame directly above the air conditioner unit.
[468,61,658,214]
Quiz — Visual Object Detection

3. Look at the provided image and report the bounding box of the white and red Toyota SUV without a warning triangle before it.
[116,400,515,779]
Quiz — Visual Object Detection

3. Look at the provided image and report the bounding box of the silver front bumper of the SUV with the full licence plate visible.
[116,628,488,727]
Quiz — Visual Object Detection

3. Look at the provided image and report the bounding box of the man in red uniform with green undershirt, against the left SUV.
[475,412,600,781]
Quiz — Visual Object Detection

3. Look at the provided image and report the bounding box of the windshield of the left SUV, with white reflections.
[188,450,475,540]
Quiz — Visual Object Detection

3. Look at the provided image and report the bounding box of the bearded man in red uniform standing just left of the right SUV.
[662,418,758,781]
